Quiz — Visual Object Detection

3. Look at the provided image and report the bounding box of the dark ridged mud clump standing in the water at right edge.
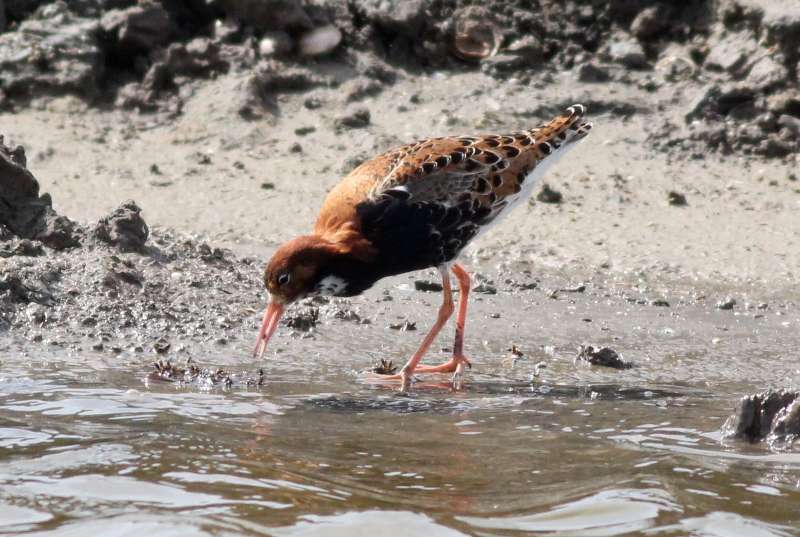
[722,390,800,448]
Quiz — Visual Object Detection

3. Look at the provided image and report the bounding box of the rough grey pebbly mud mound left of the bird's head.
[0,131,263,348]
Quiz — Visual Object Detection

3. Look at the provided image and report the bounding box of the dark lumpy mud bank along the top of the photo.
[0,0,800,158]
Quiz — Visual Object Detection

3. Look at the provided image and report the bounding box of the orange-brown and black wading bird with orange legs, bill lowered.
[254,104,592,390]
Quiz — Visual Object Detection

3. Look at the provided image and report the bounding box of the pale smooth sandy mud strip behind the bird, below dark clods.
[0,67,800,298]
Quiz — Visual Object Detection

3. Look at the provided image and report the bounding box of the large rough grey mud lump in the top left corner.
[0,2,103,97]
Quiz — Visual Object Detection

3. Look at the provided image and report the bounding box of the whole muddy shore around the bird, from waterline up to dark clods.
[0,0,800,482]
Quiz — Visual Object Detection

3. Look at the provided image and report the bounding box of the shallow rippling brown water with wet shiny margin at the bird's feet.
[0,282,800,536]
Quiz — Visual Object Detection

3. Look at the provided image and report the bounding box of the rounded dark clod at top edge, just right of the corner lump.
[100,0,176,52]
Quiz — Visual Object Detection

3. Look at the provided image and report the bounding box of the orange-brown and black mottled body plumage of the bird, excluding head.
[314,105,591,293]
